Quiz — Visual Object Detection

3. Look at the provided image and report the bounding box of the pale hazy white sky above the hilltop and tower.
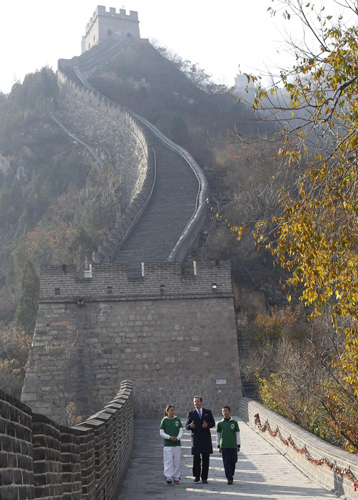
[0,0,332,93]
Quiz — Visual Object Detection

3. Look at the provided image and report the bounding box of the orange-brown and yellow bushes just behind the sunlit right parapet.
[241,306,358,452]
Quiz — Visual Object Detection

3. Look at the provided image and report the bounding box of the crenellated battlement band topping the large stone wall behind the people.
[40,261,232,303]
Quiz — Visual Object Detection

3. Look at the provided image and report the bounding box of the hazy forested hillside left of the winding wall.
[0,68,120,314]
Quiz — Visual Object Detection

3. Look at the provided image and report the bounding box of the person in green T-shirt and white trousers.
[159,405,183,484]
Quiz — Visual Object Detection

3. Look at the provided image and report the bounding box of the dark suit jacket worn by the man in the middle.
[185,408,215,455]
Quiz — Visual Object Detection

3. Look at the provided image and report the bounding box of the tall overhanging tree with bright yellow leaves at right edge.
[257,1,358,397]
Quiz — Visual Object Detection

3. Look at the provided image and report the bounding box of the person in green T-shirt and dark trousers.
[216,406,241,484]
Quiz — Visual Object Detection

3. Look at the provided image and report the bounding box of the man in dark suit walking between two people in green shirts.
[185,396,215,484]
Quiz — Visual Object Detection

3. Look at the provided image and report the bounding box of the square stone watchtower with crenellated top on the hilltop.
[82,5,140,53]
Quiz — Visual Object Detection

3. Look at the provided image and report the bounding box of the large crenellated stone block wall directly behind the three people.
[22,263,241,422]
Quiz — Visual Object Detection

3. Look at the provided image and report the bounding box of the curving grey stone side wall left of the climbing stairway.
[57,70,155,263]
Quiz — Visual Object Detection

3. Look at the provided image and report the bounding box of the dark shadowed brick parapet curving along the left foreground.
[0,381,133,500]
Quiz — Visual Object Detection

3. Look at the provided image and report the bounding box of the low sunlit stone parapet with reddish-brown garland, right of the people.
[239,398,358,500]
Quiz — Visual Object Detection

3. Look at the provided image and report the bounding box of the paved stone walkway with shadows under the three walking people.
[118,418,338,500]
